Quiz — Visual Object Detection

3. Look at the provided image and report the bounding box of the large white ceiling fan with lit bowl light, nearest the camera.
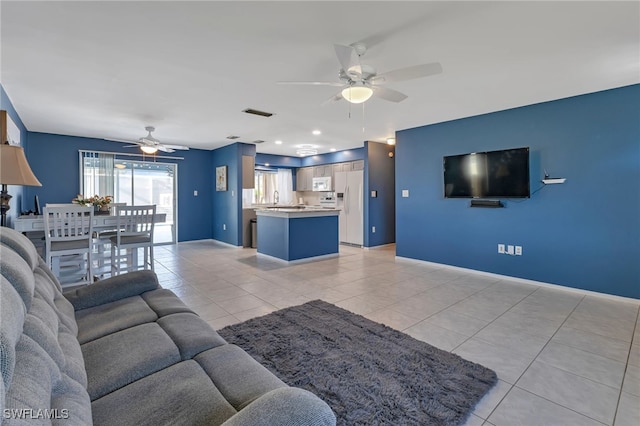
[278,43,442,104]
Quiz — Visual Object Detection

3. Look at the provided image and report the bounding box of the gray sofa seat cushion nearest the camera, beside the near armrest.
[91,360,236,426]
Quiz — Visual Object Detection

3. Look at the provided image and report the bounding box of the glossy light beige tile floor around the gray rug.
[155,240,640,426]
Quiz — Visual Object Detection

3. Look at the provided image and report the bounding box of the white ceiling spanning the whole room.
[0,0,640,155]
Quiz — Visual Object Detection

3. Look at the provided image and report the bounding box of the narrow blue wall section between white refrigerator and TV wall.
[364,142,396,247]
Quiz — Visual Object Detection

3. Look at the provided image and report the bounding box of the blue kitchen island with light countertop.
[256,207,340,262]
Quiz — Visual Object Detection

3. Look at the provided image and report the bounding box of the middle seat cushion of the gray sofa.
[81,322,181,401]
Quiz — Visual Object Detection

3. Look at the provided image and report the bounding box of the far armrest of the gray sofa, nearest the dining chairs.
[64,270,160,311]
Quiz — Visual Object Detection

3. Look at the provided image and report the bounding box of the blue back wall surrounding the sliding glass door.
[26,132,213,241]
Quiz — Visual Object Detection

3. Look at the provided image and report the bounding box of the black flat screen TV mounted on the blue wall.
[444,147,530,198]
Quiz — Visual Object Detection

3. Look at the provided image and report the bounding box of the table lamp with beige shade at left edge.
[0,143,42,226]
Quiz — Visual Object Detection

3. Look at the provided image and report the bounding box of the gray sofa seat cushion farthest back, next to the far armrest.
[76,296,158,344]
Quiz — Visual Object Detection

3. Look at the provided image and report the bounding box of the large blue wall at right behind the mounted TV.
[396,85,640,298]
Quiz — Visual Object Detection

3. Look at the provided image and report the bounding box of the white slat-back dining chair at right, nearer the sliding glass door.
[110,205,156,275]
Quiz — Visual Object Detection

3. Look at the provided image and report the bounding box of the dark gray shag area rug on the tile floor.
[218,300,498,426]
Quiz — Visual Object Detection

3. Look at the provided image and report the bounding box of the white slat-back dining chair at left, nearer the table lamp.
[43,204,93,284]
